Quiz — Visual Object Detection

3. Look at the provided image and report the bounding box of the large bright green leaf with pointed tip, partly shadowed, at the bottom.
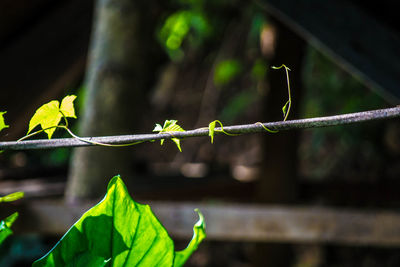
[33,176,204,267]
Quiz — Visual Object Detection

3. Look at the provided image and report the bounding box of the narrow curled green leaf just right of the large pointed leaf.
[174,209,206,267]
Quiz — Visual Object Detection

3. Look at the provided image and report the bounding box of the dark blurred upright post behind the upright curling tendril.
[254,19,305,267]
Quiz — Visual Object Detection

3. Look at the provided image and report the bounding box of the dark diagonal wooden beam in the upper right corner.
[257,0,400,104]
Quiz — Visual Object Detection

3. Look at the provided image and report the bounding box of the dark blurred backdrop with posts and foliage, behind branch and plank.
[0,0,400,267]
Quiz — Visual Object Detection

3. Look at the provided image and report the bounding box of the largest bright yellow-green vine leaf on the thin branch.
[28,95,76,139]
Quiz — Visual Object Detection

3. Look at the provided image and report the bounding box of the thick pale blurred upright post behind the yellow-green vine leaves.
[66,0,160,202]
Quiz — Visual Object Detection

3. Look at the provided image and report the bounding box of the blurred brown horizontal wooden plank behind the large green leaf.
[0,200,400,246]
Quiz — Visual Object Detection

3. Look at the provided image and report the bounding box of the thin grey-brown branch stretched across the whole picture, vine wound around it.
[0,106,400,150]
